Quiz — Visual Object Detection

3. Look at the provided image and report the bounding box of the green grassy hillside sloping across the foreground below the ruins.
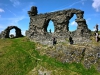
[0,37,100,75]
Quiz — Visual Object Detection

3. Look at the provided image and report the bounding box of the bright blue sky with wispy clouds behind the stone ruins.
[0,0,100,35]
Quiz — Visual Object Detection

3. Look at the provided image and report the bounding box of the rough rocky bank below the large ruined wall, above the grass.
[36,44,100,72]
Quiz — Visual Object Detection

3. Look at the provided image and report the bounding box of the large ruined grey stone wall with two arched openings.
[26,6,91,44]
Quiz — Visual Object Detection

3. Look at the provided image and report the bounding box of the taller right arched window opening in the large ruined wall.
[69,14,77,32]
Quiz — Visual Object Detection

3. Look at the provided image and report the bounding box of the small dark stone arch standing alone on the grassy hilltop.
[0,26,23,39]
